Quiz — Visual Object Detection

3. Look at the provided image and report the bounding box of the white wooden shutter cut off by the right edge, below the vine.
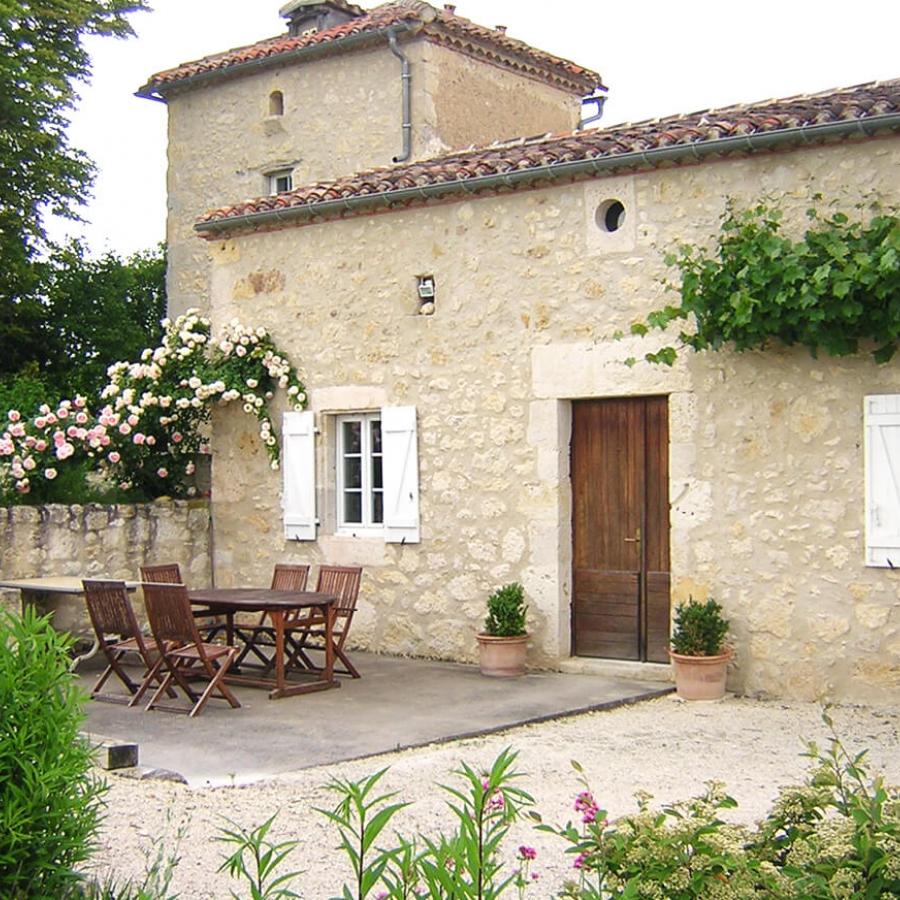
[865,394,900,568]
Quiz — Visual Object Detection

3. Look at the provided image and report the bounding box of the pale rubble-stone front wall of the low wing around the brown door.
[204,139,900,702]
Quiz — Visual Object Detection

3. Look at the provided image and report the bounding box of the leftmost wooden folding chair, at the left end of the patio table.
[81,580,175,706]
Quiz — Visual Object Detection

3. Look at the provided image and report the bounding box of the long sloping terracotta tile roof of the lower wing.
[200,79,900,230]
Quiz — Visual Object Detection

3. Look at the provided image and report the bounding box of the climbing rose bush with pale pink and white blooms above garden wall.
[0,310,306,503]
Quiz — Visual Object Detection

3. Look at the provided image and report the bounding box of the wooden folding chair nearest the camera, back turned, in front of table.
[144,583,241,718]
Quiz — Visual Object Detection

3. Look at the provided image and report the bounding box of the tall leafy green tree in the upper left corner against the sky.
[0,0,147,374]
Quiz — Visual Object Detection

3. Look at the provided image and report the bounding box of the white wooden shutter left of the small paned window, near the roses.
[281,412,316,541]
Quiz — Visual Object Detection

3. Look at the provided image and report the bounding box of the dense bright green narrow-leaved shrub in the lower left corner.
[0,609,106,898]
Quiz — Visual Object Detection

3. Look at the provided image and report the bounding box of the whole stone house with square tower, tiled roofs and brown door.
[141,0,900,702]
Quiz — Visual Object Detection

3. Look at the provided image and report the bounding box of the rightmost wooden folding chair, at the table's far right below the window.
[284,566,362,678]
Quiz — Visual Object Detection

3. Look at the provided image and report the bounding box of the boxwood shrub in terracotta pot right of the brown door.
[669,597,732,700]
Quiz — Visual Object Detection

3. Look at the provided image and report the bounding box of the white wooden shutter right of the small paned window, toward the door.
[381,406,419,544]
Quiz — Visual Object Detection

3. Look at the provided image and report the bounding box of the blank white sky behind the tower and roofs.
[51,0,900,253]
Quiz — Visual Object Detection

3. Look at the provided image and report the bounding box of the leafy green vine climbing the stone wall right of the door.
[628,198,900,365]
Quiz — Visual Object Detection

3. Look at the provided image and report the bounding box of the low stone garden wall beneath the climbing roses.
[0,500,211,626]
